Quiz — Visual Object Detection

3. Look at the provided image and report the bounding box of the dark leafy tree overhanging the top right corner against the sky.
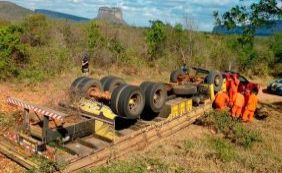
[214,0,282,47]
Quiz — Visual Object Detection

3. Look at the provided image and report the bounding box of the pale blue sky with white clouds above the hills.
[7,0,245,31]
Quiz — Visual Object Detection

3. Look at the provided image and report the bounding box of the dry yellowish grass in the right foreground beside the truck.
[88,106,282,173]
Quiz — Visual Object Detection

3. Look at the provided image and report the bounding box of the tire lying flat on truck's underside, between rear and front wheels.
[172,85,198,96]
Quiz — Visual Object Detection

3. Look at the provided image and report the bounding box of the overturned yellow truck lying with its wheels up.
[0,69,223,172]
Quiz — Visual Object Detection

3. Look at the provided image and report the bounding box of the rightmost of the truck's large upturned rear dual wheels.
[141,83,167,113]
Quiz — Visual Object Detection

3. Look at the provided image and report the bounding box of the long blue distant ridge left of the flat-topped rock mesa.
[34,9,90,22]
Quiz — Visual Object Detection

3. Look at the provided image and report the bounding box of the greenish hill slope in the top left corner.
[0,1,33,21]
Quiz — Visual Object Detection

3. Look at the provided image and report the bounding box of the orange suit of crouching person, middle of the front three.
[231,93,245,118]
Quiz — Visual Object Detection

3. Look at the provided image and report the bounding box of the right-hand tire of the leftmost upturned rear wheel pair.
[77,78,103,98]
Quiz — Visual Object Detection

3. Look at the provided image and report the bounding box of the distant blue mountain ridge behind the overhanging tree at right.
[212,20,282,36]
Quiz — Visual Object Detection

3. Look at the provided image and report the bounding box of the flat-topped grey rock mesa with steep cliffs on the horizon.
[97,7,126,24]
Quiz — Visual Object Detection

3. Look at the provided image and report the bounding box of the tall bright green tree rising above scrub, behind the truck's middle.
[146,20,166,60]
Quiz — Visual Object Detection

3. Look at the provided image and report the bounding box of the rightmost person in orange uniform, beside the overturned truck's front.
[242,89,258,122]
